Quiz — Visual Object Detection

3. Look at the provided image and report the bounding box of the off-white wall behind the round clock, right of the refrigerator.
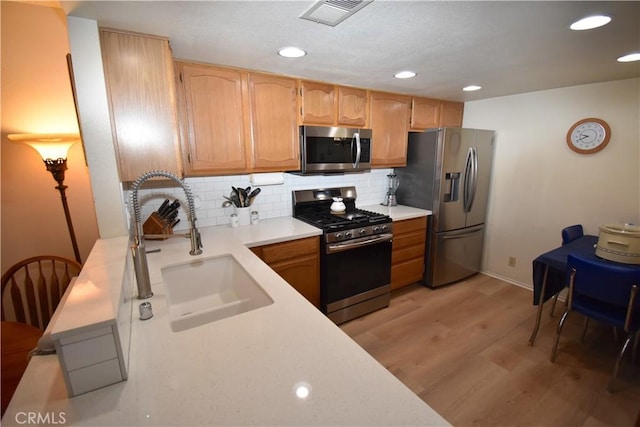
[464,79,640,286]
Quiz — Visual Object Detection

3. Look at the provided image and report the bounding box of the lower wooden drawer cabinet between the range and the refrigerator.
[391,216,427,290]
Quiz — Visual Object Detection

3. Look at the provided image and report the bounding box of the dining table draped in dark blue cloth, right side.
[529,235,602,345]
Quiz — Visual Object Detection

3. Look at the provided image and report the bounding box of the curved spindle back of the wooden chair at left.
[0,255,82,330]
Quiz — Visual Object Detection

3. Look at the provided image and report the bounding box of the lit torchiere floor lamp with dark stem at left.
[8,134,82,263]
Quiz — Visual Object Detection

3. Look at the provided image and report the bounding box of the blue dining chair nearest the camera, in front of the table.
[551,254,640,392]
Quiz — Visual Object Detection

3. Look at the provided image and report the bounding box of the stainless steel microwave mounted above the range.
[300,126,373,174]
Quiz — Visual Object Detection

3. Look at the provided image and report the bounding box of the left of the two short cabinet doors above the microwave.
[300,80,335,126]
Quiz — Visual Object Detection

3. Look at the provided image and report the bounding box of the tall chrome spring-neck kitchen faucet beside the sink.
[130,171,202,299]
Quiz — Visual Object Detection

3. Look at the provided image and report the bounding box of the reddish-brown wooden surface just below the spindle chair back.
[0,320,43,414]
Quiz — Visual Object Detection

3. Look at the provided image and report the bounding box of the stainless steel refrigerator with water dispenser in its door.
[395,128,495,287]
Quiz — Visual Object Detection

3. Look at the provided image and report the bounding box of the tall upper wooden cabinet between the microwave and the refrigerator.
[371,92,411,168]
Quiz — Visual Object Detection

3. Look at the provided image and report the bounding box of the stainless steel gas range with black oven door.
[293,187,393,324]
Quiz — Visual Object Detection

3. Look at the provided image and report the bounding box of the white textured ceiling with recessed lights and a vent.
[60,0,640,101]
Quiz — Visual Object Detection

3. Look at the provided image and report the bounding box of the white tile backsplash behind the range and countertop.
[123,169,392,230]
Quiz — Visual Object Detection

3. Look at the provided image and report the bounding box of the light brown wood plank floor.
[341,274,640,427]
